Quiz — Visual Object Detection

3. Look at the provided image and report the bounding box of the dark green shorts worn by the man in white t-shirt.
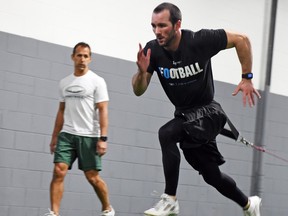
[54,132,102,171]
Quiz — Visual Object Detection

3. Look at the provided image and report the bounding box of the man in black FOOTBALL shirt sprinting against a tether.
[132,3,261,216]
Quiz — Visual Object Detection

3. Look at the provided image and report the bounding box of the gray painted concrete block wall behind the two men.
[0,32,288,216]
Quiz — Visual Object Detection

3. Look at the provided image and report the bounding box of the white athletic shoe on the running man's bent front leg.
[144,194,179,216]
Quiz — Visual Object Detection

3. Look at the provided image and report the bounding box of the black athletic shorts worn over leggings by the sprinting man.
[175,101,227,173]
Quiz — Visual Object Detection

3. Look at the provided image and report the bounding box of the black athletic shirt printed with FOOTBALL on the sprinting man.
[145,29,227,108]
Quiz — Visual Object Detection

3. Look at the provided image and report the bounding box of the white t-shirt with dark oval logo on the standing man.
[59,70,109,137]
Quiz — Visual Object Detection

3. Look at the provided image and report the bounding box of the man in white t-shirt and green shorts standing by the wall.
[46,42,115,216]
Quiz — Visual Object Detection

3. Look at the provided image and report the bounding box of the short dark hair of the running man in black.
[153,2,182,25]
